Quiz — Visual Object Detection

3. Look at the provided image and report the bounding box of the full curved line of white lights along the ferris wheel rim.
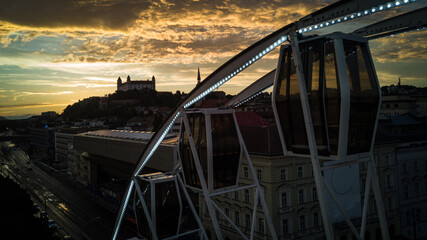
[112,0,425,239]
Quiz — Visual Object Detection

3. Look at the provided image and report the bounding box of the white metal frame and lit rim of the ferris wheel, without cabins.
[112,0,427,240]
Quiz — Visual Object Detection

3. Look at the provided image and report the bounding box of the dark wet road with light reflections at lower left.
[1,142,132,239]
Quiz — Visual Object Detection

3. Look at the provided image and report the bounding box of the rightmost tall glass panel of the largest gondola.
[343,40,379,155]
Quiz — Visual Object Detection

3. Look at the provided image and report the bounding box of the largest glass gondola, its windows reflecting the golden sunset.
[273,33,380,159]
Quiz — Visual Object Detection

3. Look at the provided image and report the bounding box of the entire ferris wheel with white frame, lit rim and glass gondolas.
[112,0,427,240]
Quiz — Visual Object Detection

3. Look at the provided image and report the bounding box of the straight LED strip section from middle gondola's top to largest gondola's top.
[184,36,288,108]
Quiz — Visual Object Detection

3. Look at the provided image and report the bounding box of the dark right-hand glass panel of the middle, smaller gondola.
[211,114,240,189]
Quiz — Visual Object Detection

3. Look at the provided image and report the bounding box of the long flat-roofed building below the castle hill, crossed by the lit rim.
[73,130,177,204]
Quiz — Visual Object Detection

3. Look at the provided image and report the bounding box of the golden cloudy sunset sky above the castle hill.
[0,0,427,117]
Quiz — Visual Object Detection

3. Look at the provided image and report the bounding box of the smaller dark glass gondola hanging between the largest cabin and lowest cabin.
[179,109,242,192]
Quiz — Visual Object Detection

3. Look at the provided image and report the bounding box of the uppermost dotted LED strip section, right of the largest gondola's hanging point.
[298,0,417,33]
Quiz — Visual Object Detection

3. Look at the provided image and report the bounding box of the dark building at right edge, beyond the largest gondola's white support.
[374,114,427,239]
